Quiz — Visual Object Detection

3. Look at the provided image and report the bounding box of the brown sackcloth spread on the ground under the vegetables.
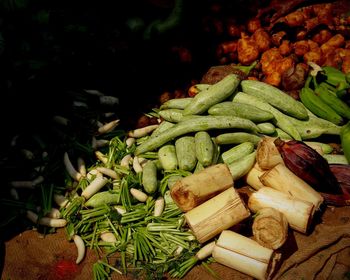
[1,207,350,280]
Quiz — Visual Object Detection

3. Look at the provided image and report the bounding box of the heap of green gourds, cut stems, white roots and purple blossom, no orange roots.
[3,60,350,279]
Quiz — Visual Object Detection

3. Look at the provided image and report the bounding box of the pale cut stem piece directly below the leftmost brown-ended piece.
[185,187,250,243]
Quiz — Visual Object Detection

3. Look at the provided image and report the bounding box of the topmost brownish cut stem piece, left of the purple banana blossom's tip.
[256,136,283,169]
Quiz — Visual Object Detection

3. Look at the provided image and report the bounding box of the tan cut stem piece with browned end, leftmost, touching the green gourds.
[171,163,233,212]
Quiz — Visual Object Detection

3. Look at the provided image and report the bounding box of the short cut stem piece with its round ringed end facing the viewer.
[252,207,288,250]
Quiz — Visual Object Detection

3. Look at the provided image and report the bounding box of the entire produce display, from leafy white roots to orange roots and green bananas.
[2,1,350,279]
